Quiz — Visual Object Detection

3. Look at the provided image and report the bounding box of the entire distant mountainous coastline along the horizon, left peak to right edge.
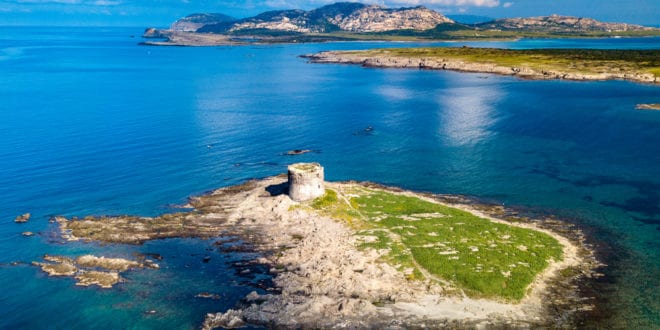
[152,2,660,44]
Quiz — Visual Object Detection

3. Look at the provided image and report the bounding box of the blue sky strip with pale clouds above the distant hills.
[0,0,660,27]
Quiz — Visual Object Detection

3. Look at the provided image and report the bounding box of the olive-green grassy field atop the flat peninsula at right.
[350,47,660,77]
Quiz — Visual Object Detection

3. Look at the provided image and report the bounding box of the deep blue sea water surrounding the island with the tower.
[0,28,660,328]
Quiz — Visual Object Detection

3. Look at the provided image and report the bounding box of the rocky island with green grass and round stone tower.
[49,163,598,328]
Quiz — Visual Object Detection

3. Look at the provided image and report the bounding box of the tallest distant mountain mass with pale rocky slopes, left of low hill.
[188,2,453,33]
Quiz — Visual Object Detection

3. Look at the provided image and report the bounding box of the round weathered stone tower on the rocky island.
[289,163,325,202]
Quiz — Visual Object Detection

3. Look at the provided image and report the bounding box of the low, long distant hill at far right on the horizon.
[476,15,654,33]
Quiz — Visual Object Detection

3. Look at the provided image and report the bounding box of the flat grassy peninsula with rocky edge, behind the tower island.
[302,47,660,84]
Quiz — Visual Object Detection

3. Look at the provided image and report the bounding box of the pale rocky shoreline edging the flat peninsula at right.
[301,51,660,84]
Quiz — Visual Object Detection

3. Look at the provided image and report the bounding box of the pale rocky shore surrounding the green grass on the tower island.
[50,176,599,329]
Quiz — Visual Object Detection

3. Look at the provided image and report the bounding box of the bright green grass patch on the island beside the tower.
[310,187,562,301]
